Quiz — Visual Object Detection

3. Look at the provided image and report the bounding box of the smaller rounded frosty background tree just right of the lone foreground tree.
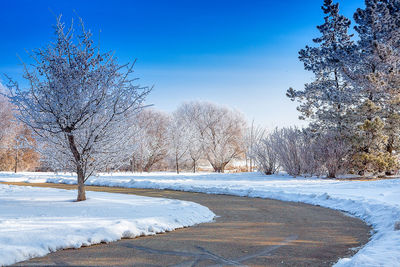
[133,109,170,172]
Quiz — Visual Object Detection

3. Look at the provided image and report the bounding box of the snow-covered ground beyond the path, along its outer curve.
[0,173,400,266]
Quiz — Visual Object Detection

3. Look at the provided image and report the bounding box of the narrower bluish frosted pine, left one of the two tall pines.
[287,0,353,135]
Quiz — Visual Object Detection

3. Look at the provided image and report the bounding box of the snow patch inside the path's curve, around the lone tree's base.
[0,182,215,266]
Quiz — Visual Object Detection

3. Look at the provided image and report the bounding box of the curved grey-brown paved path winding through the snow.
[4,183,370,266]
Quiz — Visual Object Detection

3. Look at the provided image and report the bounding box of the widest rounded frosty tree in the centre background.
[177,101,246,172]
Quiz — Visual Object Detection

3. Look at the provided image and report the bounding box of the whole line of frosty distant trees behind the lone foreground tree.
[0,91,248,173]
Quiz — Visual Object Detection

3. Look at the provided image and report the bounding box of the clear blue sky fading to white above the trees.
[0,0,363,128]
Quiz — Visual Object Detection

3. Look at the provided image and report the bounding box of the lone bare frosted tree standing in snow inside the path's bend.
[8,16,150,201]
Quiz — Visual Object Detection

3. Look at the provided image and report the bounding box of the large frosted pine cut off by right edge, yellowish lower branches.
[344,0,400,174]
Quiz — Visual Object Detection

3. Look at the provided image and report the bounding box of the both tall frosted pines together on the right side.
[287,0,400,177]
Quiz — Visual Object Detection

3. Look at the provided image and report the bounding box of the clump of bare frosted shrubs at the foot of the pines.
[252,127,351,178]
